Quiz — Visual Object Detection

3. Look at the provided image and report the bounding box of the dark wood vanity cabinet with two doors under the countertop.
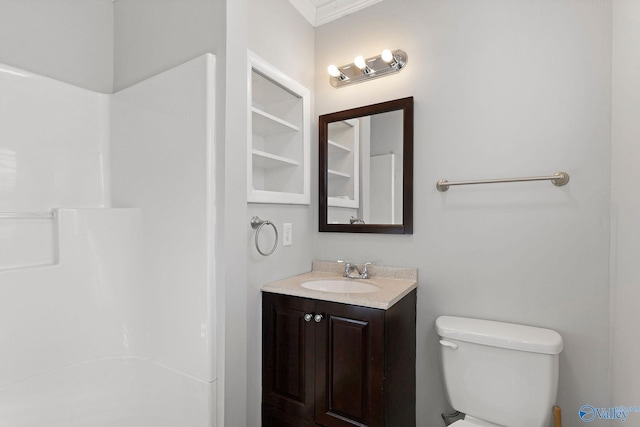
[262,290,416,427]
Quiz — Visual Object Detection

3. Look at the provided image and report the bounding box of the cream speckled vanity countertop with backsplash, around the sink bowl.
[262,261,418,310]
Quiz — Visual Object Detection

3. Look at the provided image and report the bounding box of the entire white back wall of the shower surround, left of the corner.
[0,61,139,426]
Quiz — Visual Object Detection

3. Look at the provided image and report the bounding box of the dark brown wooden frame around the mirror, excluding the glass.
[318,97,413,234]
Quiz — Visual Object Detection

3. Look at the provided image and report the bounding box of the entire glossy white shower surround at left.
[0,55,217,427]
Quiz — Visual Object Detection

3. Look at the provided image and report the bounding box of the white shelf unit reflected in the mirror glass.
[327,119,360,209]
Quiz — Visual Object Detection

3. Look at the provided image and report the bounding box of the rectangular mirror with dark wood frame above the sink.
[319,97,413,234]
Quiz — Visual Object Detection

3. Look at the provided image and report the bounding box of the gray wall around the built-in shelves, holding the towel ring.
[245,0,318,426]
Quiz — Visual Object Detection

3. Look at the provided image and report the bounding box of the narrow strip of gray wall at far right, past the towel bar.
[611,0,640,414]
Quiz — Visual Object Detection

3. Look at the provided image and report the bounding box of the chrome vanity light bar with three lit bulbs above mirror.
[327,49,408,87]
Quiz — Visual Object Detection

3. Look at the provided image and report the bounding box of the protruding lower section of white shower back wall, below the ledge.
[0,209,139,384]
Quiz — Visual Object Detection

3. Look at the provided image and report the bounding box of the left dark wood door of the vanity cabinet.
[262,294,316,426]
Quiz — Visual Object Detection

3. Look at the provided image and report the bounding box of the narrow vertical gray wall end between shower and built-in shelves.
[222,0,251,426]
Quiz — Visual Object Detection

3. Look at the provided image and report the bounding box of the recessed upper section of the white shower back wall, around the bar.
[0,65,109,271]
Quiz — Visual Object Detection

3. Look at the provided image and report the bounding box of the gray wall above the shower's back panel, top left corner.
[0,0,113,93]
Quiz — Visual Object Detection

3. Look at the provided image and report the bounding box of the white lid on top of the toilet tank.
[436,316,563,354]
